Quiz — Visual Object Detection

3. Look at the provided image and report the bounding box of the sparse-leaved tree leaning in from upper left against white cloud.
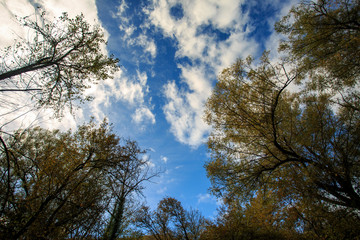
[0,12,118,114]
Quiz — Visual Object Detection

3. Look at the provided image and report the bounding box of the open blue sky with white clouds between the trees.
[0,0,297,218]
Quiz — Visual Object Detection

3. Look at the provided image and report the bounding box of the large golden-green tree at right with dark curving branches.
[205,57,360,239]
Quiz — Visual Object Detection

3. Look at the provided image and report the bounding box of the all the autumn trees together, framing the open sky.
[0,0,360,240]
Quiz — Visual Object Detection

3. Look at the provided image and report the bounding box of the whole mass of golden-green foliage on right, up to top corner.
[205,0,360,239]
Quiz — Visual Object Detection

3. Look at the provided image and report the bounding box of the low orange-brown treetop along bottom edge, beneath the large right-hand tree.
[201,189,360,240]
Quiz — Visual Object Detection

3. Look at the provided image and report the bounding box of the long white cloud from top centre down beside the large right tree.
[148,0,257,147]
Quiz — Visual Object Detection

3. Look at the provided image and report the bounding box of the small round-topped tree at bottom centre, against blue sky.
[136,197,206,240]
